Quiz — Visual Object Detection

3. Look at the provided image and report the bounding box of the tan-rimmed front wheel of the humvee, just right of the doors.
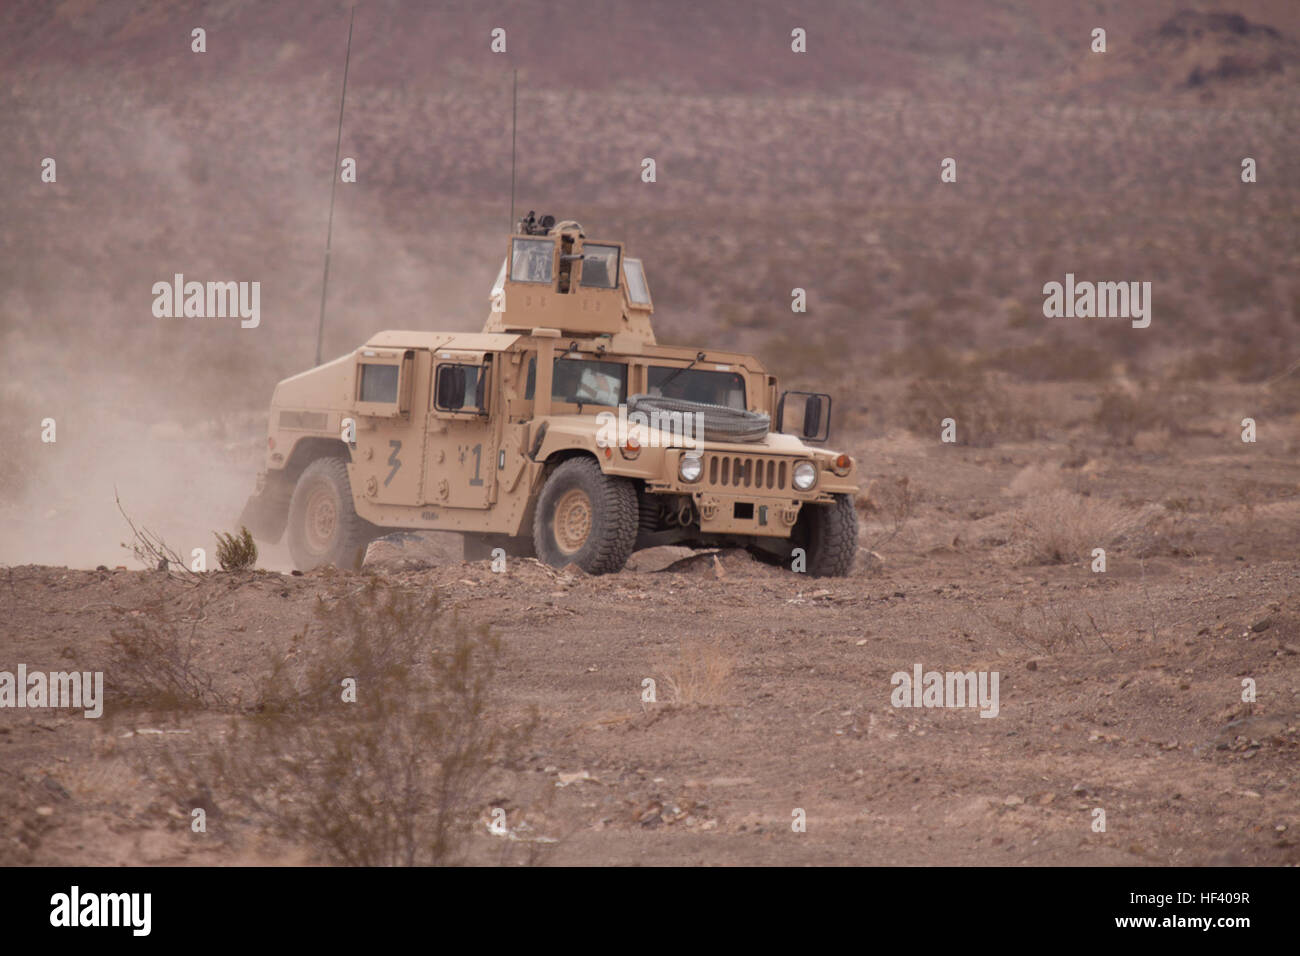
[533,457,638,575]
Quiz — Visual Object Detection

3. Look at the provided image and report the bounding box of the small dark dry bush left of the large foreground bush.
[101,593,226,710]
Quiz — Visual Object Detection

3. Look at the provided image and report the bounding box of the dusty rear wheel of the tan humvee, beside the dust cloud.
[289,458,384,571]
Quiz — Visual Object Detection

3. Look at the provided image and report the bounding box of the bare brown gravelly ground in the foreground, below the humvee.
[0,386,1300,865]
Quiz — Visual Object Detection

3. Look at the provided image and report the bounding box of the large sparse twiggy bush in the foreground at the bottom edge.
[164,579,534,866]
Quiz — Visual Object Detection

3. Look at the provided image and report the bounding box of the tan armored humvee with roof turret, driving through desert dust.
[241,213,858,576]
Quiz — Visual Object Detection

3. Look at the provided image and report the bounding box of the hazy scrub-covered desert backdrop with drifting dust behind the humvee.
[0,0,1300,566]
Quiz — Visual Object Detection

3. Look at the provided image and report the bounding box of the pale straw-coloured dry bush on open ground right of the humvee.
[1009,490,1135,564]
